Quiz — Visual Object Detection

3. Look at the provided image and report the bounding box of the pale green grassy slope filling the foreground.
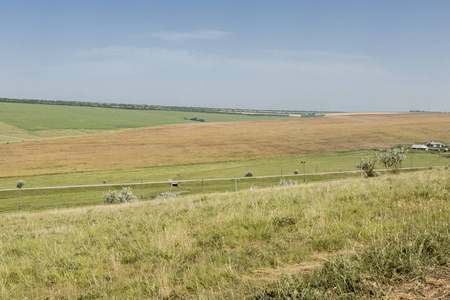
[0,170,450,299]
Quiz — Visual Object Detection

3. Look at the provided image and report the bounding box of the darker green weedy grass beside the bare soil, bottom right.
[253,228,450,299]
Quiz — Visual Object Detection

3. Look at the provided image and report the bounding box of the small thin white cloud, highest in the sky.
[139,30,233,42]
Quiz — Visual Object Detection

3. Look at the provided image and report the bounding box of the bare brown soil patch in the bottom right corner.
[386,267,450,300]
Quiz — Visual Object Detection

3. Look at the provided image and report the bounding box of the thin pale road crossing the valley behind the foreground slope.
[0,166,440,192]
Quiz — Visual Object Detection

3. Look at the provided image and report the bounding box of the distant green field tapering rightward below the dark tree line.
[0,102,288,143]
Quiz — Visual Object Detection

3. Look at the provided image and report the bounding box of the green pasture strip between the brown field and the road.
[0,150,450,189]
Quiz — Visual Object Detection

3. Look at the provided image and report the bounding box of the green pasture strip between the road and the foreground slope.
[0,173,359,213]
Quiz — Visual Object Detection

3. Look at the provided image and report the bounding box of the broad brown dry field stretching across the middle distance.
[0,114,450,177]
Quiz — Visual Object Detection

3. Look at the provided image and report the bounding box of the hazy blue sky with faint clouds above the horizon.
[0,0,450,111]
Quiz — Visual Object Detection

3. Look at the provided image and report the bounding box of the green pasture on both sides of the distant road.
[0,150,450,212]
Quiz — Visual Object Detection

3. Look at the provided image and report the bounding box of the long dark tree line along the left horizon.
[0,98,324,117]
